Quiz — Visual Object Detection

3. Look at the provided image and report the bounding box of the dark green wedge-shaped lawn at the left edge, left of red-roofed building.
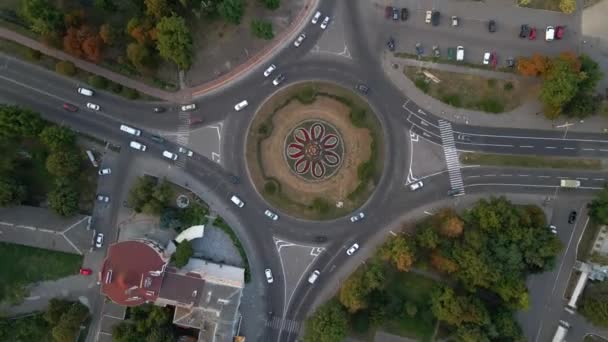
[0,242,82,301]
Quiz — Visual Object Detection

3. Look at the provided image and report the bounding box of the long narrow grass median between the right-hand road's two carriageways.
[460,152,603,170]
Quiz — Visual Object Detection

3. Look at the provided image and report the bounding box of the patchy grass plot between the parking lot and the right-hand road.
[403,66,536,113]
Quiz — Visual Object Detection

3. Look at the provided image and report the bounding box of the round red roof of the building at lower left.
[101,241,166,306]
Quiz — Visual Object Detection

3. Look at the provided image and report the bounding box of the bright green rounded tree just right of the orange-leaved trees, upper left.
[156,15,192,70]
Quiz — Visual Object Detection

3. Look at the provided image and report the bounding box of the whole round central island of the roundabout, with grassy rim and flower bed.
[246,82,383,220]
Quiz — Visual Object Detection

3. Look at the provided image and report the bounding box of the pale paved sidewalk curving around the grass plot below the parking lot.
[382,53,608,133]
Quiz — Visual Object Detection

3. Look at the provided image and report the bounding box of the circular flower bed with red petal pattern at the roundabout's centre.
[285,120,344,181]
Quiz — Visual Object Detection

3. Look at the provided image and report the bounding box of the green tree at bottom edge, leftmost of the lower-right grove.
[304,300,348,342]
